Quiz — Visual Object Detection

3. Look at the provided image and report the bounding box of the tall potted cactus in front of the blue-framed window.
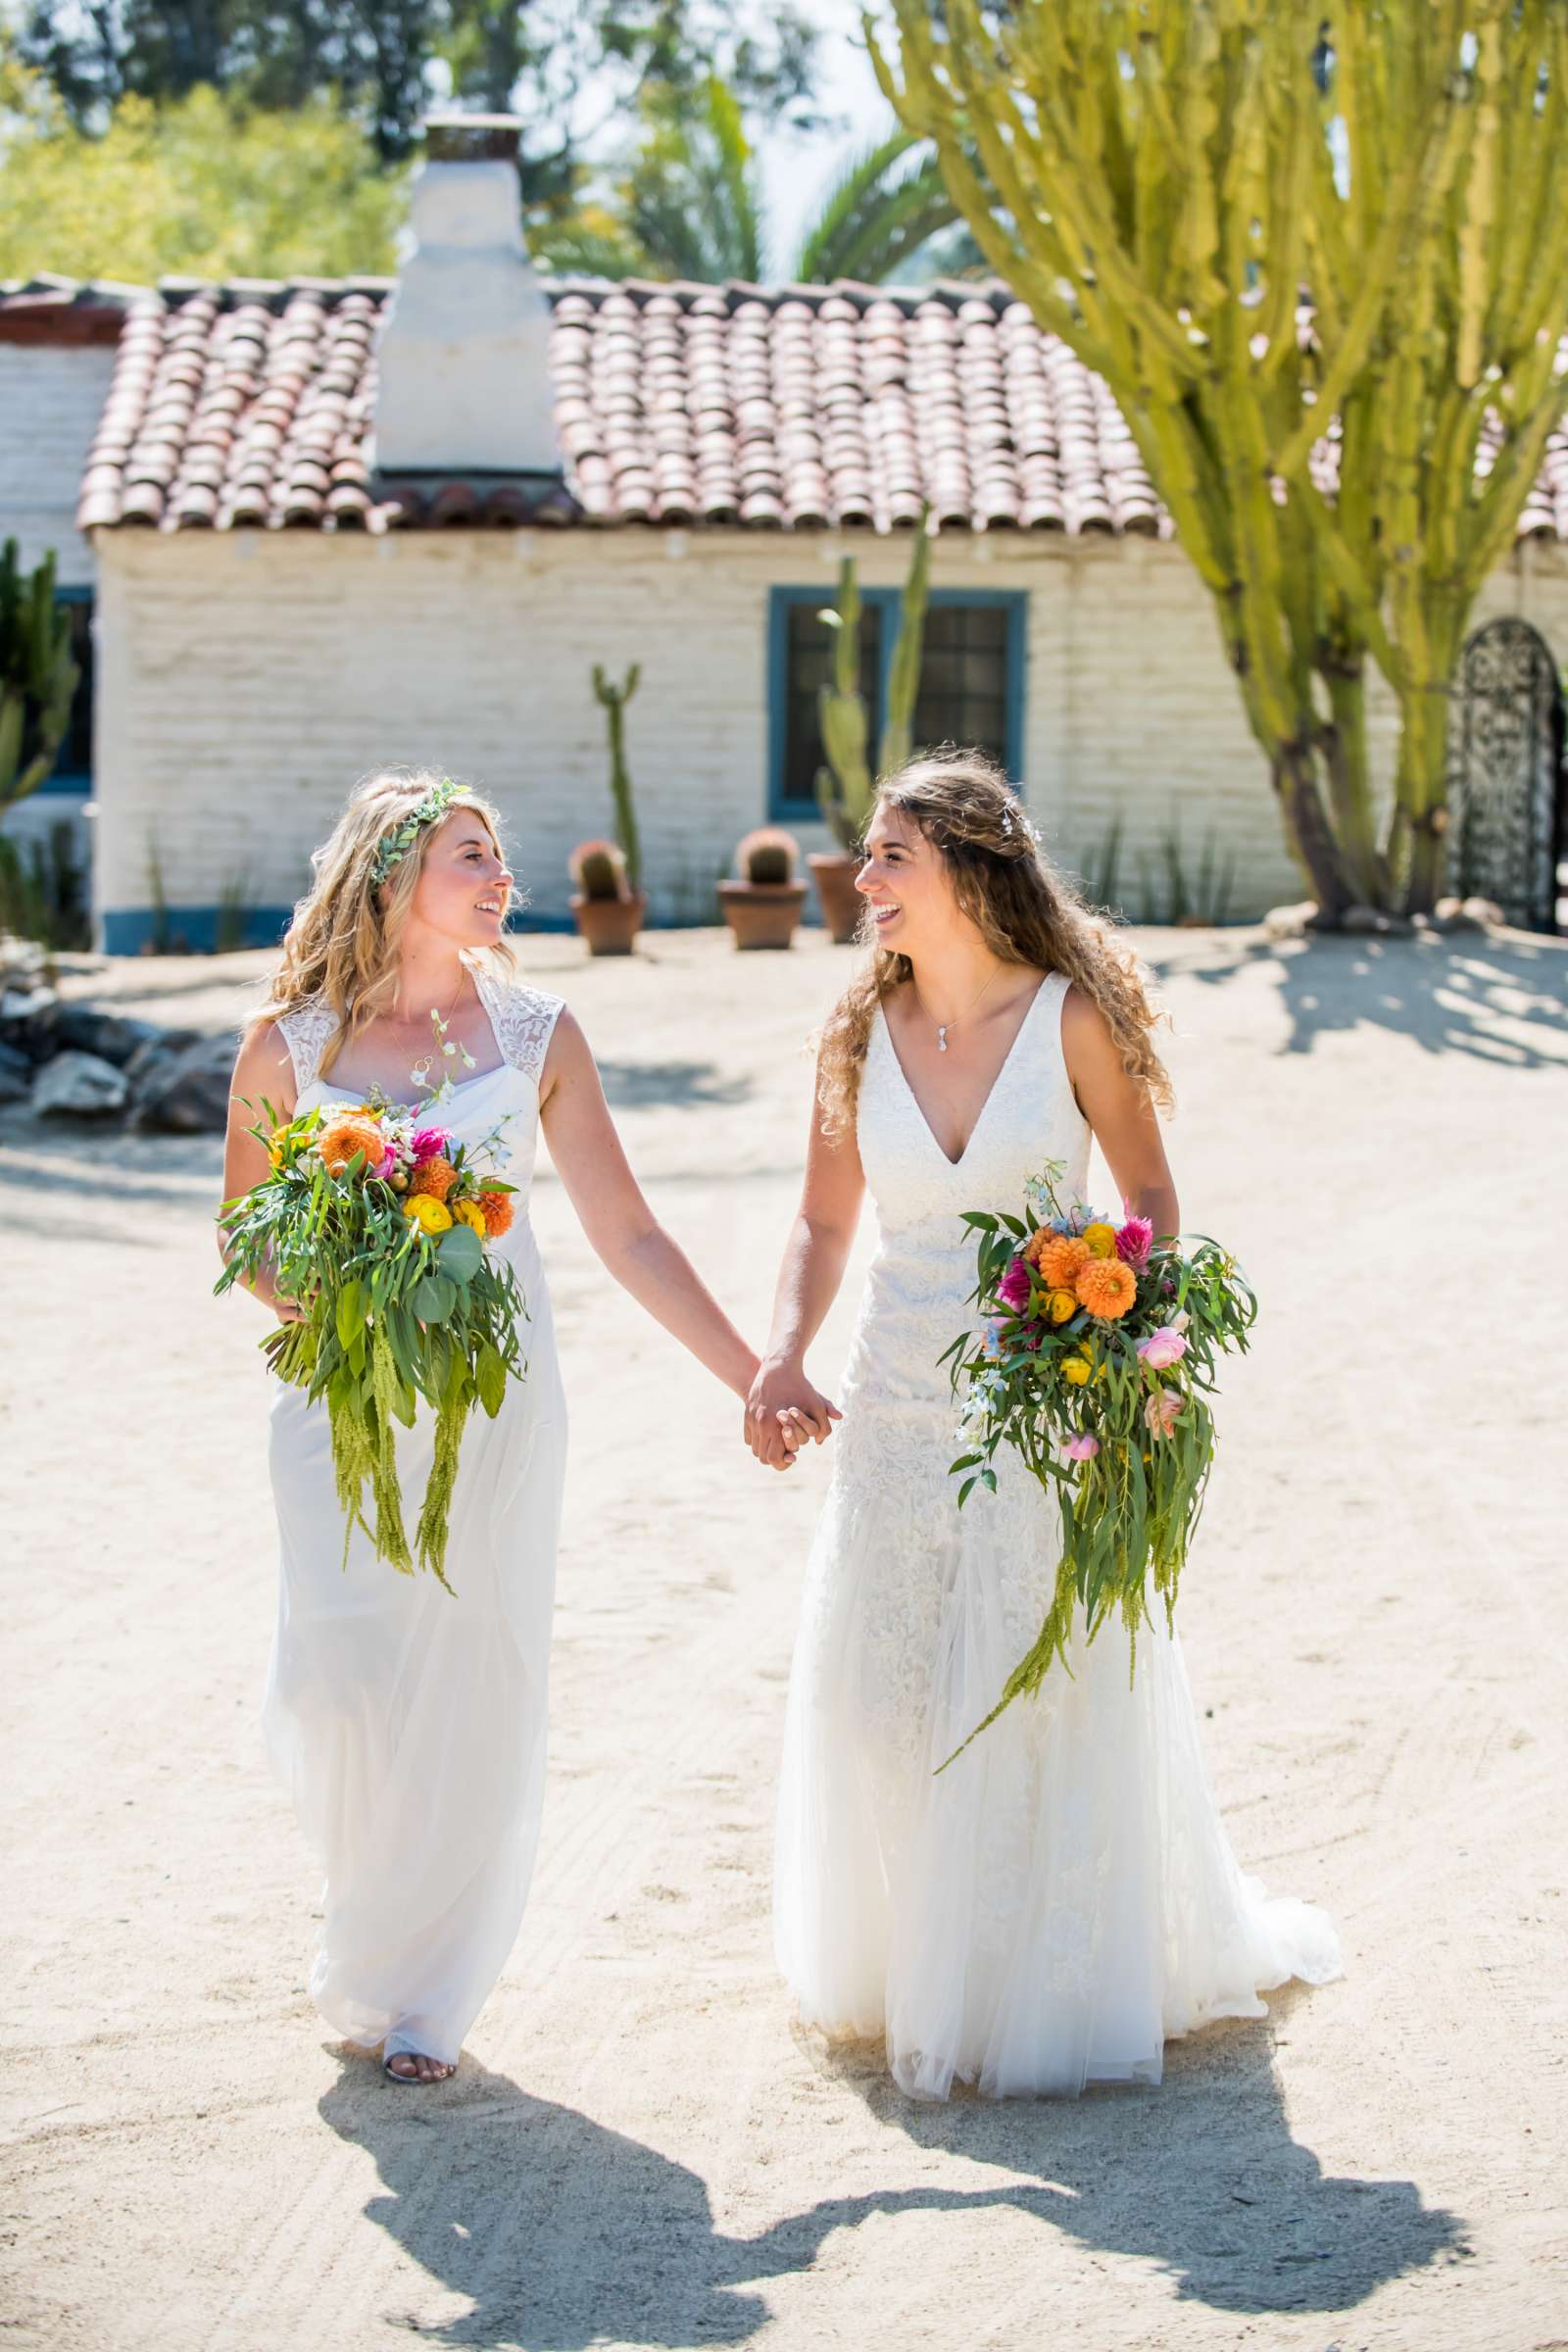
[808,506,931,948]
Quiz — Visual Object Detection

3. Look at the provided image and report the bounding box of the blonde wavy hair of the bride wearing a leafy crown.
[247,766,517,1075]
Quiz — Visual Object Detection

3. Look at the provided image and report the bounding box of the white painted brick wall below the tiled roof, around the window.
[94,529,1568,945]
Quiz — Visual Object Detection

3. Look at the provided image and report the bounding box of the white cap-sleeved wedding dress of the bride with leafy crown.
[264,969,566,2063]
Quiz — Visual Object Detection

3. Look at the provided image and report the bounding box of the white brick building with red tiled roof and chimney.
[0,117,1568,951]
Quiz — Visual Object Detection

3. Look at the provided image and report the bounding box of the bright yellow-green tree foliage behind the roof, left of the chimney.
[0,64,407,284]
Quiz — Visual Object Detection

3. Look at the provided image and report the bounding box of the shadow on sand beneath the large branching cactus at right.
[1163,931,1568,1070]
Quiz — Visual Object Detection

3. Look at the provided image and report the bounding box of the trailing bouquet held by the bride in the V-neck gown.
[941,1164,1257,1745]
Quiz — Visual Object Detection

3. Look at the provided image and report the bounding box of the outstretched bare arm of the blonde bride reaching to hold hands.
[538,1011,757,1397]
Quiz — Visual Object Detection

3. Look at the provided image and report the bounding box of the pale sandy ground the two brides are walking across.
[0,931,1568,2352]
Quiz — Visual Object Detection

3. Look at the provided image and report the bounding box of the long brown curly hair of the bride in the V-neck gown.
[818,748,1173,1141]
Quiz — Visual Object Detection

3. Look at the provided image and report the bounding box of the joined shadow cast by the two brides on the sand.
[319,1997,1467,2352]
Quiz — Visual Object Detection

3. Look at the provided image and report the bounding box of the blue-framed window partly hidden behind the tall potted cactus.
[768,583,1030,823]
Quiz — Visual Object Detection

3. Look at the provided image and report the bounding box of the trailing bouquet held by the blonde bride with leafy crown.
[217,1096,526,1590]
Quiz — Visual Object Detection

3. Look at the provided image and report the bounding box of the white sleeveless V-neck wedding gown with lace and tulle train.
[776,974,1340,2098]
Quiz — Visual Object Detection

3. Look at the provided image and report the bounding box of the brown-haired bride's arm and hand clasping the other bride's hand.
[745,1067,865,1460]
